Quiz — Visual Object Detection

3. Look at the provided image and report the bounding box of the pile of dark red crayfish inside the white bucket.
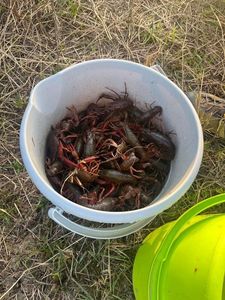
[45,89,176,211]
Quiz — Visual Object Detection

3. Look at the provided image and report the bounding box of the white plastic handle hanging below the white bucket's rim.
[48,207,154,239]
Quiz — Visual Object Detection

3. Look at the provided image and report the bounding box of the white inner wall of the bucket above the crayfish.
[24,60,200,213]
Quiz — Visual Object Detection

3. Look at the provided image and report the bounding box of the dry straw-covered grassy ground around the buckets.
[0,0,225,300]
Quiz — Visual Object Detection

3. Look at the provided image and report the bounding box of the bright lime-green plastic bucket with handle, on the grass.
[133,194,225,300]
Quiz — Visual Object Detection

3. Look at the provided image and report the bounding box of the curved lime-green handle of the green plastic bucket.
[149,193,225,299]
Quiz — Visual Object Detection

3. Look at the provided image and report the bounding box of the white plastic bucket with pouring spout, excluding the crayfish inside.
[20,59,203,239]
